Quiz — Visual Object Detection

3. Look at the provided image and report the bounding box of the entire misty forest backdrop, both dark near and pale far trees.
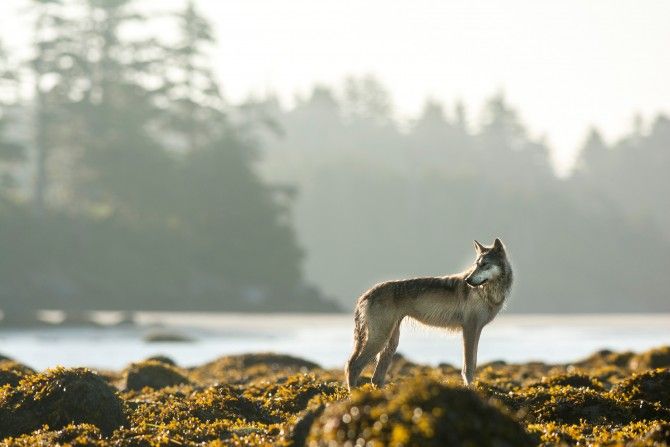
[0,0,670,322]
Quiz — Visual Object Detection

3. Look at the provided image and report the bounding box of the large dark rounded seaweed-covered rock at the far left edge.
[0,367,125,439]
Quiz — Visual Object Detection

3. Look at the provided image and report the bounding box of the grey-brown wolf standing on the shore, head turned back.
[345,238,513,390]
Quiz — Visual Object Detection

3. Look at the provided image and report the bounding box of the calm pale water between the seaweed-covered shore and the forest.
[0,314,670,369]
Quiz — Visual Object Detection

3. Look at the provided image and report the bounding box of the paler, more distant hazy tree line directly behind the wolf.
[262,76,670,312]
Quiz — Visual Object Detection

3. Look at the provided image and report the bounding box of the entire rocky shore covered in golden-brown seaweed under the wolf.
[0,347,670,447]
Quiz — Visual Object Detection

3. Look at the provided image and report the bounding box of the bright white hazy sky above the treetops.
[0,0,670,172]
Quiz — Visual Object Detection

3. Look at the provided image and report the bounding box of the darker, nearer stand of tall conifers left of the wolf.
[0,0,336,326]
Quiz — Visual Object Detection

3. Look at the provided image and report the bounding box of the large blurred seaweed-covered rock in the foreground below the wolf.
[308,377,534,447]
